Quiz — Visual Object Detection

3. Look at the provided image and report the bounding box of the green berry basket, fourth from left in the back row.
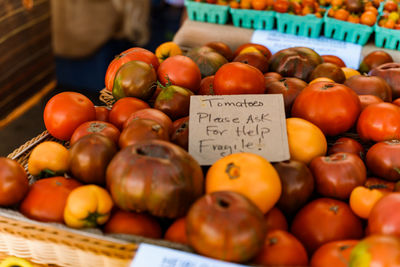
[324,7,374,45]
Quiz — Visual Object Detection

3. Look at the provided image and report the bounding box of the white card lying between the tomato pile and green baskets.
[251,30,362,69]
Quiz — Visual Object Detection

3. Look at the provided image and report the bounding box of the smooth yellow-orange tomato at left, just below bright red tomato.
[28,141,69,178]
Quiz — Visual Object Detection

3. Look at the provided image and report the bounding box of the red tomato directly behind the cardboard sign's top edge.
[213,62,265,95]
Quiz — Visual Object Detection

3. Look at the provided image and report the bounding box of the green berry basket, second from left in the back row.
[230,8,275,30]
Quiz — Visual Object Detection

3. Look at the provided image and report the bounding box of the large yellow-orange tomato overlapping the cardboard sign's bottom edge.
[206,152,282,213]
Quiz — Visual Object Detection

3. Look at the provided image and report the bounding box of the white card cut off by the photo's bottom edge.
[130,243,247,267]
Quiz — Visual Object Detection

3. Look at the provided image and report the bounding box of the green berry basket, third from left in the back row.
[275,13,324,38]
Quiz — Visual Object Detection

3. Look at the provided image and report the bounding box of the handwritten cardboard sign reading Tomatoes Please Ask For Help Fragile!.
[189,94,290,165]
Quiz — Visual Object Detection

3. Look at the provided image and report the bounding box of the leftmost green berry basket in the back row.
[185,0,229,24]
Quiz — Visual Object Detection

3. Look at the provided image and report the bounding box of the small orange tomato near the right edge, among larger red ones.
[349,186,384,219]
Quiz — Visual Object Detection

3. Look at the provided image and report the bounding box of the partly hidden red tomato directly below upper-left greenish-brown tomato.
[109,97,150,130]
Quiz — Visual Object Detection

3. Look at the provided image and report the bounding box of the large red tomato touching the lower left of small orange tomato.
[291,198,363,254]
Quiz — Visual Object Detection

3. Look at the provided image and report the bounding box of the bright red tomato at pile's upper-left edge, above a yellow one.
[43,92,96,141]
